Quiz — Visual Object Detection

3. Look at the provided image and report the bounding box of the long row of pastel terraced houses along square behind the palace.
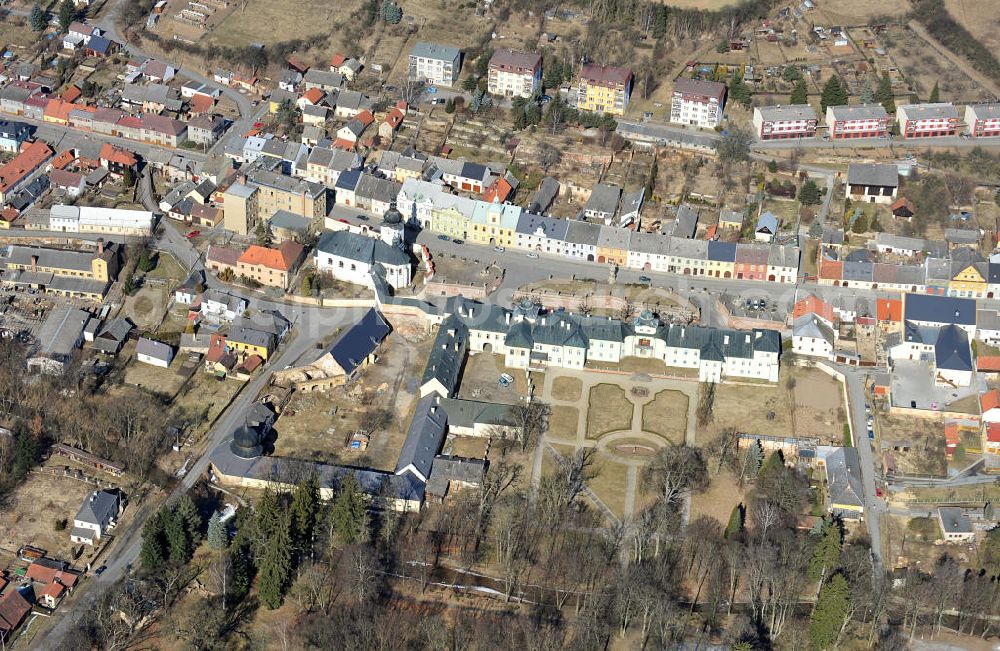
[396,179,800,283]
